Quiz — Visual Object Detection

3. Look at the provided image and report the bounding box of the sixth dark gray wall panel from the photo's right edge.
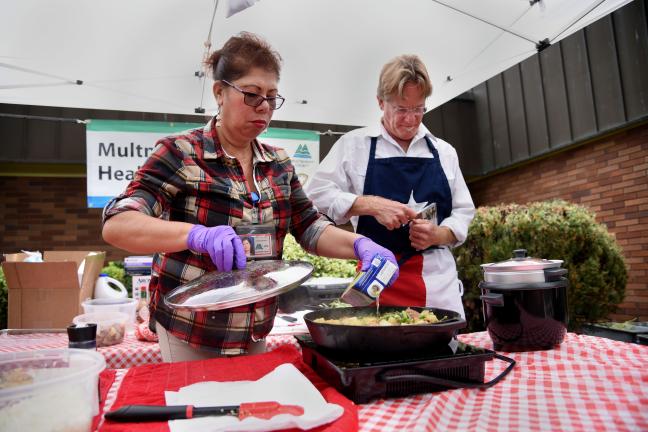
[502,66,529,162]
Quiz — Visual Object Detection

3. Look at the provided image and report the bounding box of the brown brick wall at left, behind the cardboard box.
[0,177,125,260]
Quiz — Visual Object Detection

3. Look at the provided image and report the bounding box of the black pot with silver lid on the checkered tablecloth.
[479,250,569,351]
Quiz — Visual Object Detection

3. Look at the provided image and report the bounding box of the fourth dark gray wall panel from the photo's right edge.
[540,45,571,148]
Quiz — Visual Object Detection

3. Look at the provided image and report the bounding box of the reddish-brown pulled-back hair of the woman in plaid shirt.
[206,32,281,81]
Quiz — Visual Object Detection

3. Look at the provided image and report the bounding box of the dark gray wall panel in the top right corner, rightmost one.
[613,1,648,120]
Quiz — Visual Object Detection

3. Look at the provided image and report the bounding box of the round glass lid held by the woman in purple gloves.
[164,260,313,311]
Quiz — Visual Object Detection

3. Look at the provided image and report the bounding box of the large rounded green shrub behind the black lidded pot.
[454,201,627,331]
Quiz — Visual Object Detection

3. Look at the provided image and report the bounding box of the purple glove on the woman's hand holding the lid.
[187,225,245,271]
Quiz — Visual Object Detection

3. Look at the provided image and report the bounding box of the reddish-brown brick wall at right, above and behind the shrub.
[469,124,648,321]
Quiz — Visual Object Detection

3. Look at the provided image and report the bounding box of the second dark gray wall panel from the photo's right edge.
[585,16,625,129]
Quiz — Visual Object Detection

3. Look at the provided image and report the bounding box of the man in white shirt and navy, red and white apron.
[305,55,475,316]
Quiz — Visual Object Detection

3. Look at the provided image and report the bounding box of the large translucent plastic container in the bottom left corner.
[0,349,106,432]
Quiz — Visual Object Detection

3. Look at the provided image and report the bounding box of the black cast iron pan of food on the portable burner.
[304,306,466,357]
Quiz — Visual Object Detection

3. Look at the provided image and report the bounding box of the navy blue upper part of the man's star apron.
[356,136,452,257]
